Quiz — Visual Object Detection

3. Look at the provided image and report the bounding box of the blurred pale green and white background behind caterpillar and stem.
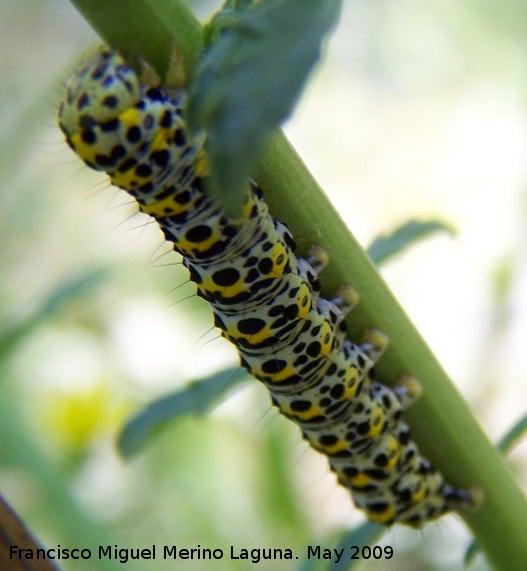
[0,0,527,571]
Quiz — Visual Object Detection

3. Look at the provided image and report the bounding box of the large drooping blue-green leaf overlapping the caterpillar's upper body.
[187,0,341,214]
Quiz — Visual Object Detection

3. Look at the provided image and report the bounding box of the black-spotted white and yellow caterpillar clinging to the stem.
[58,48,477,527]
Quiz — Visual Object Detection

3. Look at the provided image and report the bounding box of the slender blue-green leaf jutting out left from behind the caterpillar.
[117,367,248,458]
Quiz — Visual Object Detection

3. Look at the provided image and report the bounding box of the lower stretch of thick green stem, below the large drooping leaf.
[258,134,527,571]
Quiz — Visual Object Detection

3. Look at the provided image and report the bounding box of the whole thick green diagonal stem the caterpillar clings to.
[65,0,527,571]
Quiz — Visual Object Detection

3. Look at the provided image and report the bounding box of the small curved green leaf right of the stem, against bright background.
[367,220,455,265]
